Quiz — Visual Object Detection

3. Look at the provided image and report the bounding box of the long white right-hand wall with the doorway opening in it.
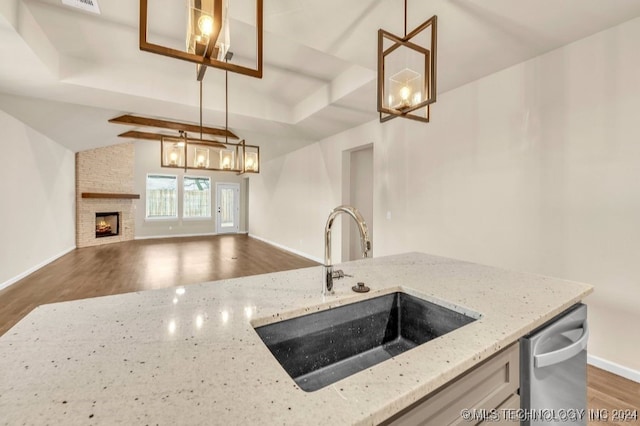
[250,18,640,371]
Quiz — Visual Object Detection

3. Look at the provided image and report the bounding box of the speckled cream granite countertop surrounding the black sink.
[0,253,593,425]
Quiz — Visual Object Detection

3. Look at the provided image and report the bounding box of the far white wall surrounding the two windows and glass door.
[134,141,248,238]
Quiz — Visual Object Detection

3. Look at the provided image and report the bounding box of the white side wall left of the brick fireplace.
[0,110,75,288]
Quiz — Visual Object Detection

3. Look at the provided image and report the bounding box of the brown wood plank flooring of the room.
[0,235,640,420]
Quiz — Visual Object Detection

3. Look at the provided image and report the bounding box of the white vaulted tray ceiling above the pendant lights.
[0,0,640,158]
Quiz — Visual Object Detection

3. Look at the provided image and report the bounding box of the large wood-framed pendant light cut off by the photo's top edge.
[139,0,263,80]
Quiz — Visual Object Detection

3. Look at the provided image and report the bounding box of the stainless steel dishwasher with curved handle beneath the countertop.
[520,303,589,426]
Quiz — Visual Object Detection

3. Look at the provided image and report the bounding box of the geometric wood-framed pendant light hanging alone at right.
[378,0,438,123]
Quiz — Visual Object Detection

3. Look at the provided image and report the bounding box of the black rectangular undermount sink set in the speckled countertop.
[255,292,480,392]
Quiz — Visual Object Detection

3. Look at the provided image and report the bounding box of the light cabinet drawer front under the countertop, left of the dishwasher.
[383,342,520,426]
